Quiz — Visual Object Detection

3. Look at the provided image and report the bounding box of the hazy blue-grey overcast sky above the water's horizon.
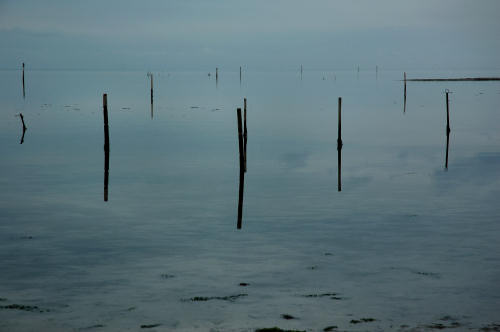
[0,0,500,70]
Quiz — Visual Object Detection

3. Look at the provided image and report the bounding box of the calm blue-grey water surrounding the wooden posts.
[0,69,500,331]
